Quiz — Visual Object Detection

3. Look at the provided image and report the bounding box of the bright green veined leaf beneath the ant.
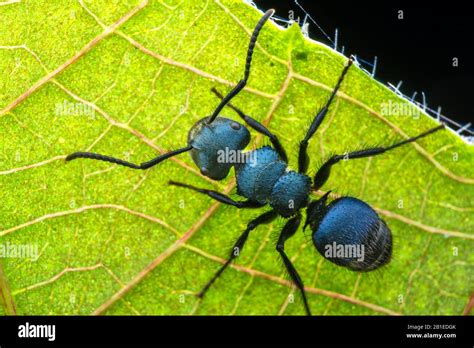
[0,0,474,315]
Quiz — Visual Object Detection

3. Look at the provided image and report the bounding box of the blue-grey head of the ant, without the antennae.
[188,117,250,180]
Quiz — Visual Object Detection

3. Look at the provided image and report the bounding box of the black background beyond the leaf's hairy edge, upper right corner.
[254,0,474,128]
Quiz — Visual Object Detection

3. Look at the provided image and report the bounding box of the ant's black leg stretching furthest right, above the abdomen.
[313,124,444,190]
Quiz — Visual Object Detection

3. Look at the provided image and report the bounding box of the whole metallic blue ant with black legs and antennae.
[66,10,444,315]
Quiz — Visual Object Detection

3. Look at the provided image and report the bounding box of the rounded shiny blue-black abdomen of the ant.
[312,197,392,272]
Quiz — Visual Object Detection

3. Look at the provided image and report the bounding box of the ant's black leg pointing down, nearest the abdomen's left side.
[276,214,311,315]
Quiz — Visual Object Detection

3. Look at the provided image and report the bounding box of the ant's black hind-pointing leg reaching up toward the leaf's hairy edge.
[298,56,354,173]
